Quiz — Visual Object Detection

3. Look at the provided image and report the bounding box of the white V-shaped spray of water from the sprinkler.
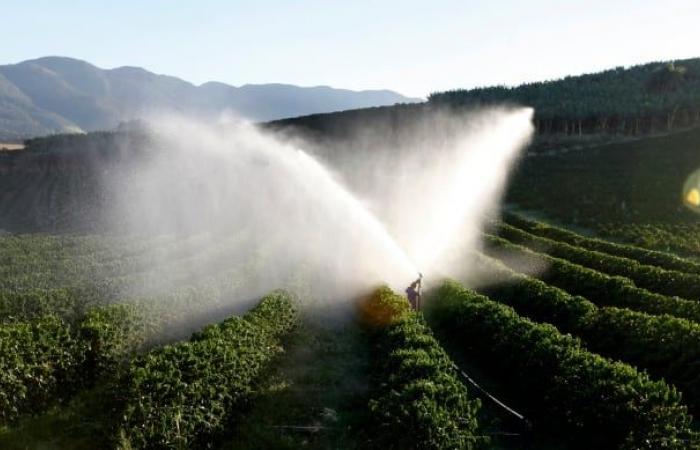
[105,109,532,326]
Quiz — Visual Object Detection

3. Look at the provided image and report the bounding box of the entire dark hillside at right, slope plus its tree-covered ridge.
[272,59,700,256]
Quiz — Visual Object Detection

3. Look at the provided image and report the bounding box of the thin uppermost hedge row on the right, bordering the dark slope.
[503,213,700,275]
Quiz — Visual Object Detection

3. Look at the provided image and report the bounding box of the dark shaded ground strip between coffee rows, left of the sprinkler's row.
[222,322,369,450]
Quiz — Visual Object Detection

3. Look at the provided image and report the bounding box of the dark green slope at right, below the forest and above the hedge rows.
[506,127,700,234]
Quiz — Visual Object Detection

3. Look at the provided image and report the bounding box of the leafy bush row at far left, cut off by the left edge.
[0,305,143,425]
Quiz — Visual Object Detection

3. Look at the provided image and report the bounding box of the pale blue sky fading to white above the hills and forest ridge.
[0,0,700,96]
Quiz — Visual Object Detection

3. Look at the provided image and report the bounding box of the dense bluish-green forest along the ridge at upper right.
[428,58,700,135]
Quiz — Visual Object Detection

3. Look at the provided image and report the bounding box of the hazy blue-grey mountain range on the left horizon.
[0,57,420,140]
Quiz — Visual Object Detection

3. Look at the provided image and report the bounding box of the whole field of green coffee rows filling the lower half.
[0,214,700,449]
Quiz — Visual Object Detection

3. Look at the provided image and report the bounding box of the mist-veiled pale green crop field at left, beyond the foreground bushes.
[0,227,270,343]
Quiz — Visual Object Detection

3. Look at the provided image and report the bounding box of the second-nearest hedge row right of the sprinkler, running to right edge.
[470,251,700,411]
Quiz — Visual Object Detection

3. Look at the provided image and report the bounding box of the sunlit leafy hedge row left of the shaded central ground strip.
[115,292,298,449]
